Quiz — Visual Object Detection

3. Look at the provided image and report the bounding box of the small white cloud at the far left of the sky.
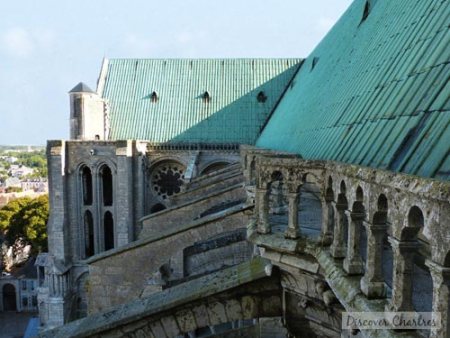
[1,27,55,58]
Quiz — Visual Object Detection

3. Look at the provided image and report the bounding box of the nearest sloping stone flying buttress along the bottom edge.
[42,258,279,338]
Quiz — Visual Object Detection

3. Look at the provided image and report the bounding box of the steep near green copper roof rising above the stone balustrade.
[257,0,450,180]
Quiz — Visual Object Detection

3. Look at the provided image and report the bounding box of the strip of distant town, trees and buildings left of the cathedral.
[0,145,48,312]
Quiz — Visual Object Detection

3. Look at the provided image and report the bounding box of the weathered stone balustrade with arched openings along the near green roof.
[241,148,450,337]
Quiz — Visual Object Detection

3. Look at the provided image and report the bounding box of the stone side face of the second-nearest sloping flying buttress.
[88,207,253,313]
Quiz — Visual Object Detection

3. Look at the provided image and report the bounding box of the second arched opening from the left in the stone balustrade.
[298,174,323,238]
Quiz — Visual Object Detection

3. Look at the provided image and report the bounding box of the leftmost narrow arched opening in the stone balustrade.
[268,170,288,232]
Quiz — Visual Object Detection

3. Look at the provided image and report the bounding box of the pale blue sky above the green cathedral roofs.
[0,0,352,145]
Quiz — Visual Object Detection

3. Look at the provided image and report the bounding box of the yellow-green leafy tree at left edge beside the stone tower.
[0,195,49,252]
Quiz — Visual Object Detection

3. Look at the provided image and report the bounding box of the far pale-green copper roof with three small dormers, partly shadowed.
[100,59,301,144]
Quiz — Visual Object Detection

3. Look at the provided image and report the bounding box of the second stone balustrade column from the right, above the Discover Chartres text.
[386,237,419,312]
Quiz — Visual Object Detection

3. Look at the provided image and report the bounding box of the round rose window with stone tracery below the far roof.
[151,162,185,199]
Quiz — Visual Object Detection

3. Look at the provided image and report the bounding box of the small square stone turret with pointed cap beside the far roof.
[69,82,105,140]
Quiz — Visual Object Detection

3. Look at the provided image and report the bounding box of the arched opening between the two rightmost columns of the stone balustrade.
[401,206,433,312]
